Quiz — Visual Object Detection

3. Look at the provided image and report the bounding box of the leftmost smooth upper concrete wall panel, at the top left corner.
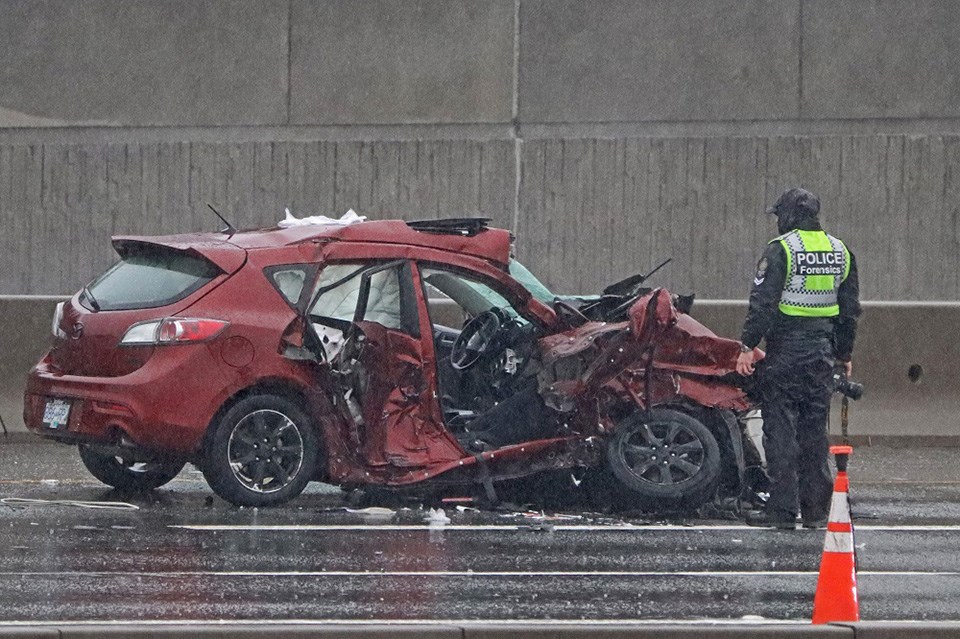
[0,0,289,127]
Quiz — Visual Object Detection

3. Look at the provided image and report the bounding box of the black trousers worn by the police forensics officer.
[761,333,834,521]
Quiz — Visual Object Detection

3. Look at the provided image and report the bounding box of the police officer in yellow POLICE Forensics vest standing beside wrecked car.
[737,188,860,530]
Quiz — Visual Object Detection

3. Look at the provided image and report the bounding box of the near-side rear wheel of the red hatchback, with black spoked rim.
[202,395,320,506]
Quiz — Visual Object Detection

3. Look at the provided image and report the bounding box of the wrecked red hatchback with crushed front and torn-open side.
[24,218,752,510]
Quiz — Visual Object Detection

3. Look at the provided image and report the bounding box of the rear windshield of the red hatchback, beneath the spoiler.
[80,246,221,311]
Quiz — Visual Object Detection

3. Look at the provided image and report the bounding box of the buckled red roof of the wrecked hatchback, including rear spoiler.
[114,220,512,266]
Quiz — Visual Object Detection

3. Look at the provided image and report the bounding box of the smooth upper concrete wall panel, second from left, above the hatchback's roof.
[290,0,514,125]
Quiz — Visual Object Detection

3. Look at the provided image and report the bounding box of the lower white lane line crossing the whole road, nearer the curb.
[0,570,960,579]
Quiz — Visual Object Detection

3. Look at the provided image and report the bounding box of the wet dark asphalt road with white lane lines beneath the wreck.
[0,440,960,622]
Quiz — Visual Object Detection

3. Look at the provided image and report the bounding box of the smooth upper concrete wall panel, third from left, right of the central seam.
[520,0,800,123]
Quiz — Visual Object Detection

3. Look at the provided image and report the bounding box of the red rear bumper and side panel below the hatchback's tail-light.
[23,345,230,456]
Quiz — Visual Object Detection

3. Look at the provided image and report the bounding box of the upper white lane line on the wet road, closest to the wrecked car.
[168,519,960,533]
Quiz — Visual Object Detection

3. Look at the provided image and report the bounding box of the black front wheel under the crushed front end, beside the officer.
[607,408,720,511]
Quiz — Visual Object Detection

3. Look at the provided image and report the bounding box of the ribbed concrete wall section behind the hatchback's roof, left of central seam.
[0,140,515,294]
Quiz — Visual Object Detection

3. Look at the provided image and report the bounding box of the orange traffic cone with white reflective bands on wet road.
[813,446,860,623]
